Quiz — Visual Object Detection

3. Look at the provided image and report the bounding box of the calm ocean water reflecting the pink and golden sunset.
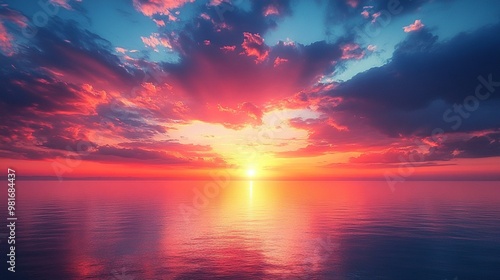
[0,180,500,280]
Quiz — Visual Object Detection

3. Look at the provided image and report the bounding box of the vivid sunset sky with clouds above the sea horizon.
[0,0,500,180]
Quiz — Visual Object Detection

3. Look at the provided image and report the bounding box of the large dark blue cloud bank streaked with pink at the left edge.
[0,17,189,162]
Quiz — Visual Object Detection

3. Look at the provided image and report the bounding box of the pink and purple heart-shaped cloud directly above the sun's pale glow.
[159,37,341,127]
